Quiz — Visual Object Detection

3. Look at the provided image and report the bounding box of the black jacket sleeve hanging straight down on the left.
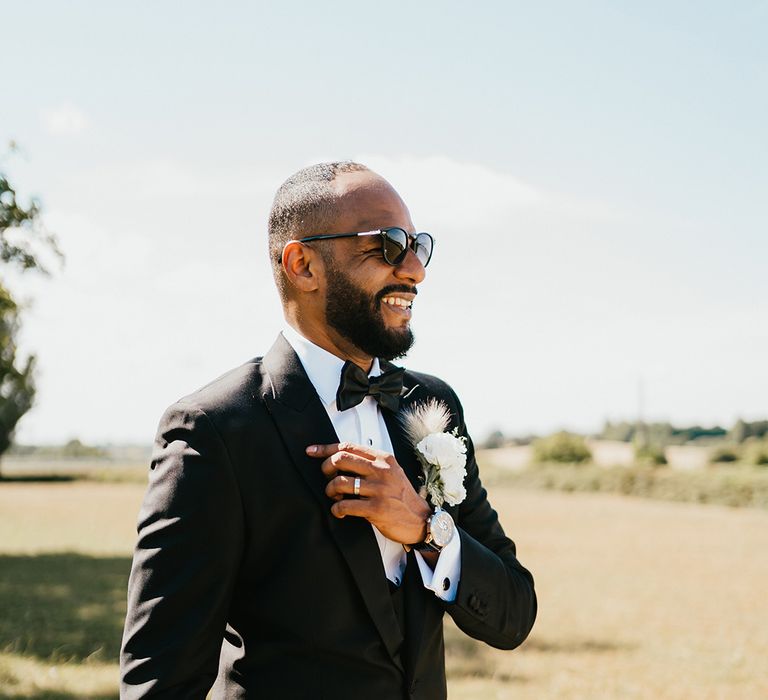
[120,404,243,700]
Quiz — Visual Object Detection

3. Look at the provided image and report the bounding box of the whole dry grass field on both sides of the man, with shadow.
[0,468,768,700]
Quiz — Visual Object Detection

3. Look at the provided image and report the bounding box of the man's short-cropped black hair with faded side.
[268,160,369,300]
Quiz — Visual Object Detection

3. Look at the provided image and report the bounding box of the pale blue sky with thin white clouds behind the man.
[0,0,768,444]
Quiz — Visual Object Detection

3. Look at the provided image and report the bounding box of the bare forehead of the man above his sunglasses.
[329,171,414,233]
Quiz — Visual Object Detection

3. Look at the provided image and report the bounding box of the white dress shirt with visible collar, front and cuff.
[283,326,461,602]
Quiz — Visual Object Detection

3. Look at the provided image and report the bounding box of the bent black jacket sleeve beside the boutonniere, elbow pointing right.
[445,394,537,649]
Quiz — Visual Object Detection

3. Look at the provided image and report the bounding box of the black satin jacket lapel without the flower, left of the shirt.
[263,334,404,671]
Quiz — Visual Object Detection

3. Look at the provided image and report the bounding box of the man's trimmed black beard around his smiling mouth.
[325,265,414,360]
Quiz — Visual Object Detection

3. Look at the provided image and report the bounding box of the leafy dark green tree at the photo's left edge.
[0,160,61,470]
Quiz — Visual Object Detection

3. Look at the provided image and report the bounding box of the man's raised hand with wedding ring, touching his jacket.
[307,442,432,544]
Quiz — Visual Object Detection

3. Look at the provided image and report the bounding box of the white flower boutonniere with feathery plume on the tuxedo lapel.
[400,399,467,508]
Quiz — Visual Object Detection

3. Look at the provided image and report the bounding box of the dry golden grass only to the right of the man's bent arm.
[448,489,768,700]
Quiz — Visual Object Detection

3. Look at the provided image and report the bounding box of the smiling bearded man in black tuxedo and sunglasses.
[121,163,536,700]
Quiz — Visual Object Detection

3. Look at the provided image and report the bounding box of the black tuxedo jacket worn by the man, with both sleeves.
[120,336,536,700]
